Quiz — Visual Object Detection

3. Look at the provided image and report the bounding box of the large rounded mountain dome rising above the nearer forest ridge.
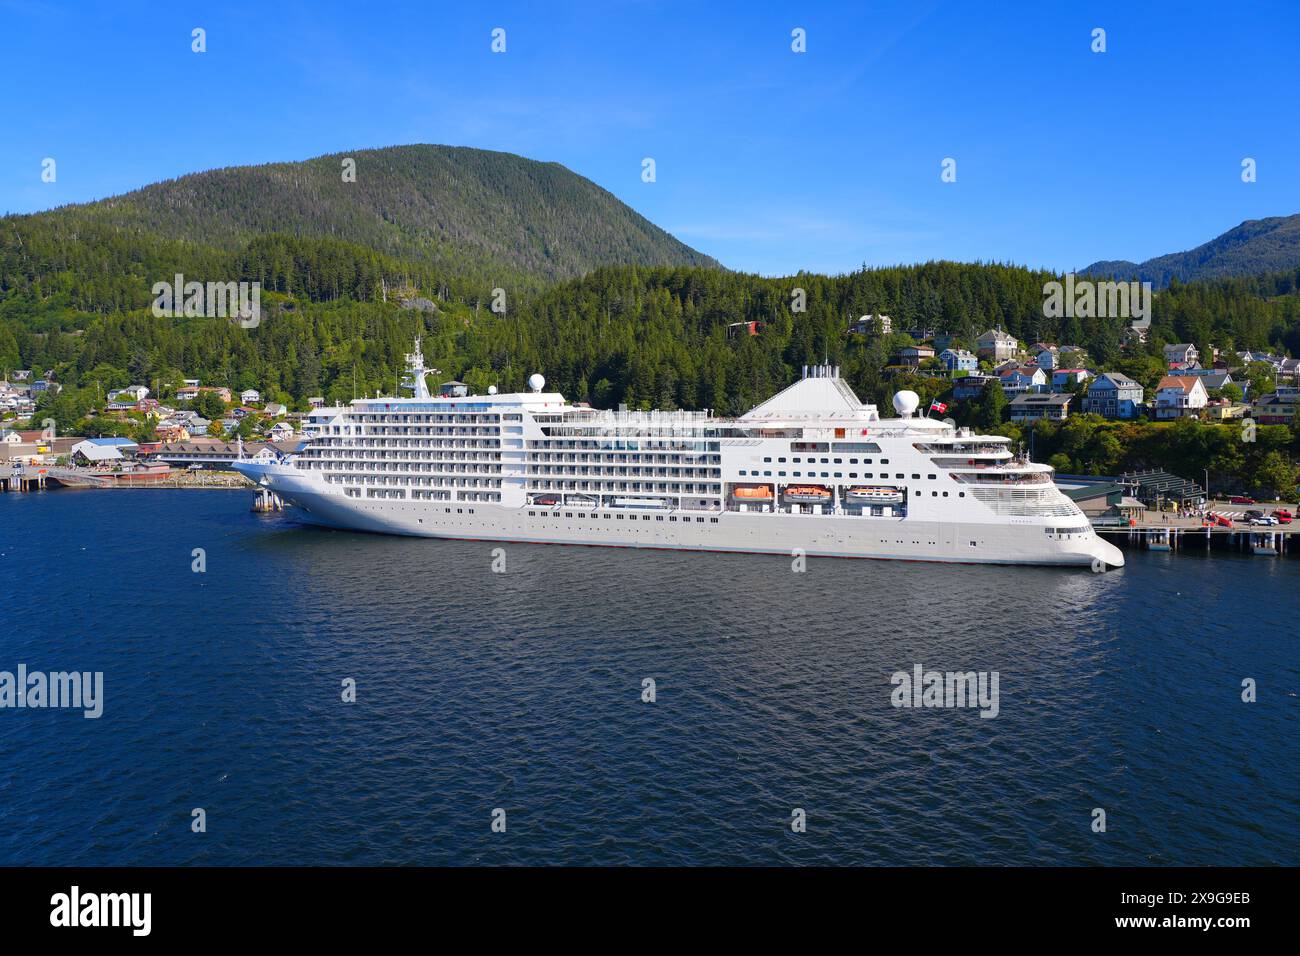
[25,144,719,281]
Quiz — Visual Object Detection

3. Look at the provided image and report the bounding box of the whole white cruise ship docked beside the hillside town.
[234,341,1125,571]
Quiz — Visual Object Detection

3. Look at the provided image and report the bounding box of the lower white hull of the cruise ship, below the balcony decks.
[237,463,1123,571]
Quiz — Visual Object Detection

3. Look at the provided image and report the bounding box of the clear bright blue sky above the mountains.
[0,0,1300,274]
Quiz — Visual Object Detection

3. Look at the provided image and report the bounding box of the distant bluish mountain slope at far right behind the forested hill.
[1080,213,1300,289]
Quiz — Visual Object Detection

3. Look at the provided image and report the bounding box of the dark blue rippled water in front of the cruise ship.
[0,490,1300,865]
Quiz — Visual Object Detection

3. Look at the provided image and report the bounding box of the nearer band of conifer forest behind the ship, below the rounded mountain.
[10,257,1300,414]
